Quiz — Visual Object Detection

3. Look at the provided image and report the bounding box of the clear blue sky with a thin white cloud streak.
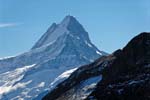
[0,0,150,57]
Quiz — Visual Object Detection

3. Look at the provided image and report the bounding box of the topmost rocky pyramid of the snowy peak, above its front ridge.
[32,15,90,49]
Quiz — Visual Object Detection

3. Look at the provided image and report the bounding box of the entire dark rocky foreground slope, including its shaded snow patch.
[43,32,150,100]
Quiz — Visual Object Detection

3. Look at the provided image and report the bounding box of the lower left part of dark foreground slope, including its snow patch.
[43,56,114,100]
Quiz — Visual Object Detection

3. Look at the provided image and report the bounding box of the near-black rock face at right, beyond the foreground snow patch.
[87,33,150,100]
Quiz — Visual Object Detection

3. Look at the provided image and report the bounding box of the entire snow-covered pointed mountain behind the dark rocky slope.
[0,16,106,100]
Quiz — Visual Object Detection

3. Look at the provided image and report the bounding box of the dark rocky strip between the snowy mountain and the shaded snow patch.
[43,56,115,100]
